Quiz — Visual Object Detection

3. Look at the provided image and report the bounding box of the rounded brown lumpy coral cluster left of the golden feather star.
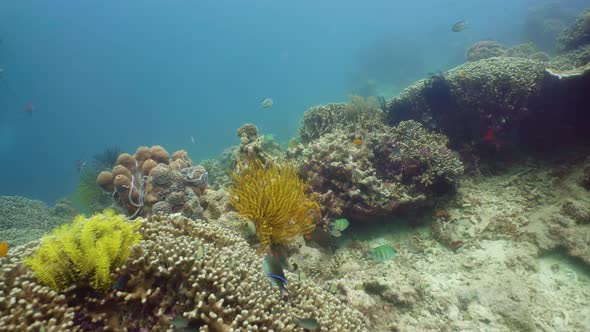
[96,145,208,218]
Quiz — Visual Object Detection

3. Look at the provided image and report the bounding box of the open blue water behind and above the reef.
[0,0,583,202]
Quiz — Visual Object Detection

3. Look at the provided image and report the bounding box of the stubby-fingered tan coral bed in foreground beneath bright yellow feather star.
[0,215,368,331]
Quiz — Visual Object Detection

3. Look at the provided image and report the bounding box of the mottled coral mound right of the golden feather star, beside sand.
[298,121,463,220]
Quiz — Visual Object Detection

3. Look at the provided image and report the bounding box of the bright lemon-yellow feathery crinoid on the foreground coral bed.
[25,210,141,291]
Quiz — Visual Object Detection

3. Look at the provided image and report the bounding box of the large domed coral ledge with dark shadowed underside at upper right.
[388,57,585,154]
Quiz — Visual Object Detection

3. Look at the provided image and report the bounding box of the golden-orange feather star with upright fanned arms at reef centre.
[230,159,321,246]
